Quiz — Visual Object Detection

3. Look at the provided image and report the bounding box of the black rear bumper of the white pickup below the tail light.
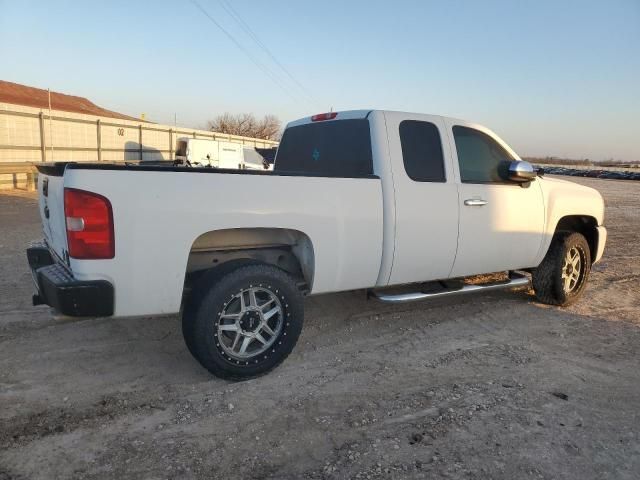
[27,244,114,317]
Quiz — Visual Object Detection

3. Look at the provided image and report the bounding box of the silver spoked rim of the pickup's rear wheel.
[216,287,284,362]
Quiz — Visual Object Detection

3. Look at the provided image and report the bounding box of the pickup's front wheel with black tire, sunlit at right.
[532,233,591,306]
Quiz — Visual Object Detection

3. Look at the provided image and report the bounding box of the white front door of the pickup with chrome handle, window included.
[447,120,544,277]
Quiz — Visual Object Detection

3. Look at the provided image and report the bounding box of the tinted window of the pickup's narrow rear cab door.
[400,120,446,182]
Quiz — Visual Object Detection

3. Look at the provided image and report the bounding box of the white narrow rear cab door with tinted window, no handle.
[384,112,458,285]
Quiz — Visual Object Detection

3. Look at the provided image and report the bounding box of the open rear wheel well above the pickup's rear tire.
[185,228,315,291]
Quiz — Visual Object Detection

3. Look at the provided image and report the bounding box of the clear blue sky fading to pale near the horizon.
[0,0,640,161]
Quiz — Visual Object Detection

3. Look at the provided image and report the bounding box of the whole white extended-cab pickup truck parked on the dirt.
[28,110,607,378]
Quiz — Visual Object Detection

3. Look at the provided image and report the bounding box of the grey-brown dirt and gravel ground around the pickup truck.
[0,179,640,480]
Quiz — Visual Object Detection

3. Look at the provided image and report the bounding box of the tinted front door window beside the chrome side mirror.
[453,125,515,183]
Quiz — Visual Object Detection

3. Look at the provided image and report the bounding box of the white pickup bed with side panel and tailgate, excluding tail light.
[38,163,383,316]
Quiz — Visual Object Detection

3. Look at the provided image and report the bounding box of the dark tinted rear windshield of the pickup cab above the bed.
[274,119,373,177]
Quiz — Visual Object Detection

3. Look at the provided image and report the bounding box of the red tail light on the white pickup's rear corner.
[64,188,115,260]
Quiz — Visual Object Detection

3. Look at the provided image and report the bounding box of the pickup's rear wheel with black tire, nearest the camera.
[182,264,304,380]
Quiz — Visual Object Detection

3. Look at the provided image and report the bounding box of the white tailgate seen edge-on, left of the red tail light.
[38,171,67,259]
